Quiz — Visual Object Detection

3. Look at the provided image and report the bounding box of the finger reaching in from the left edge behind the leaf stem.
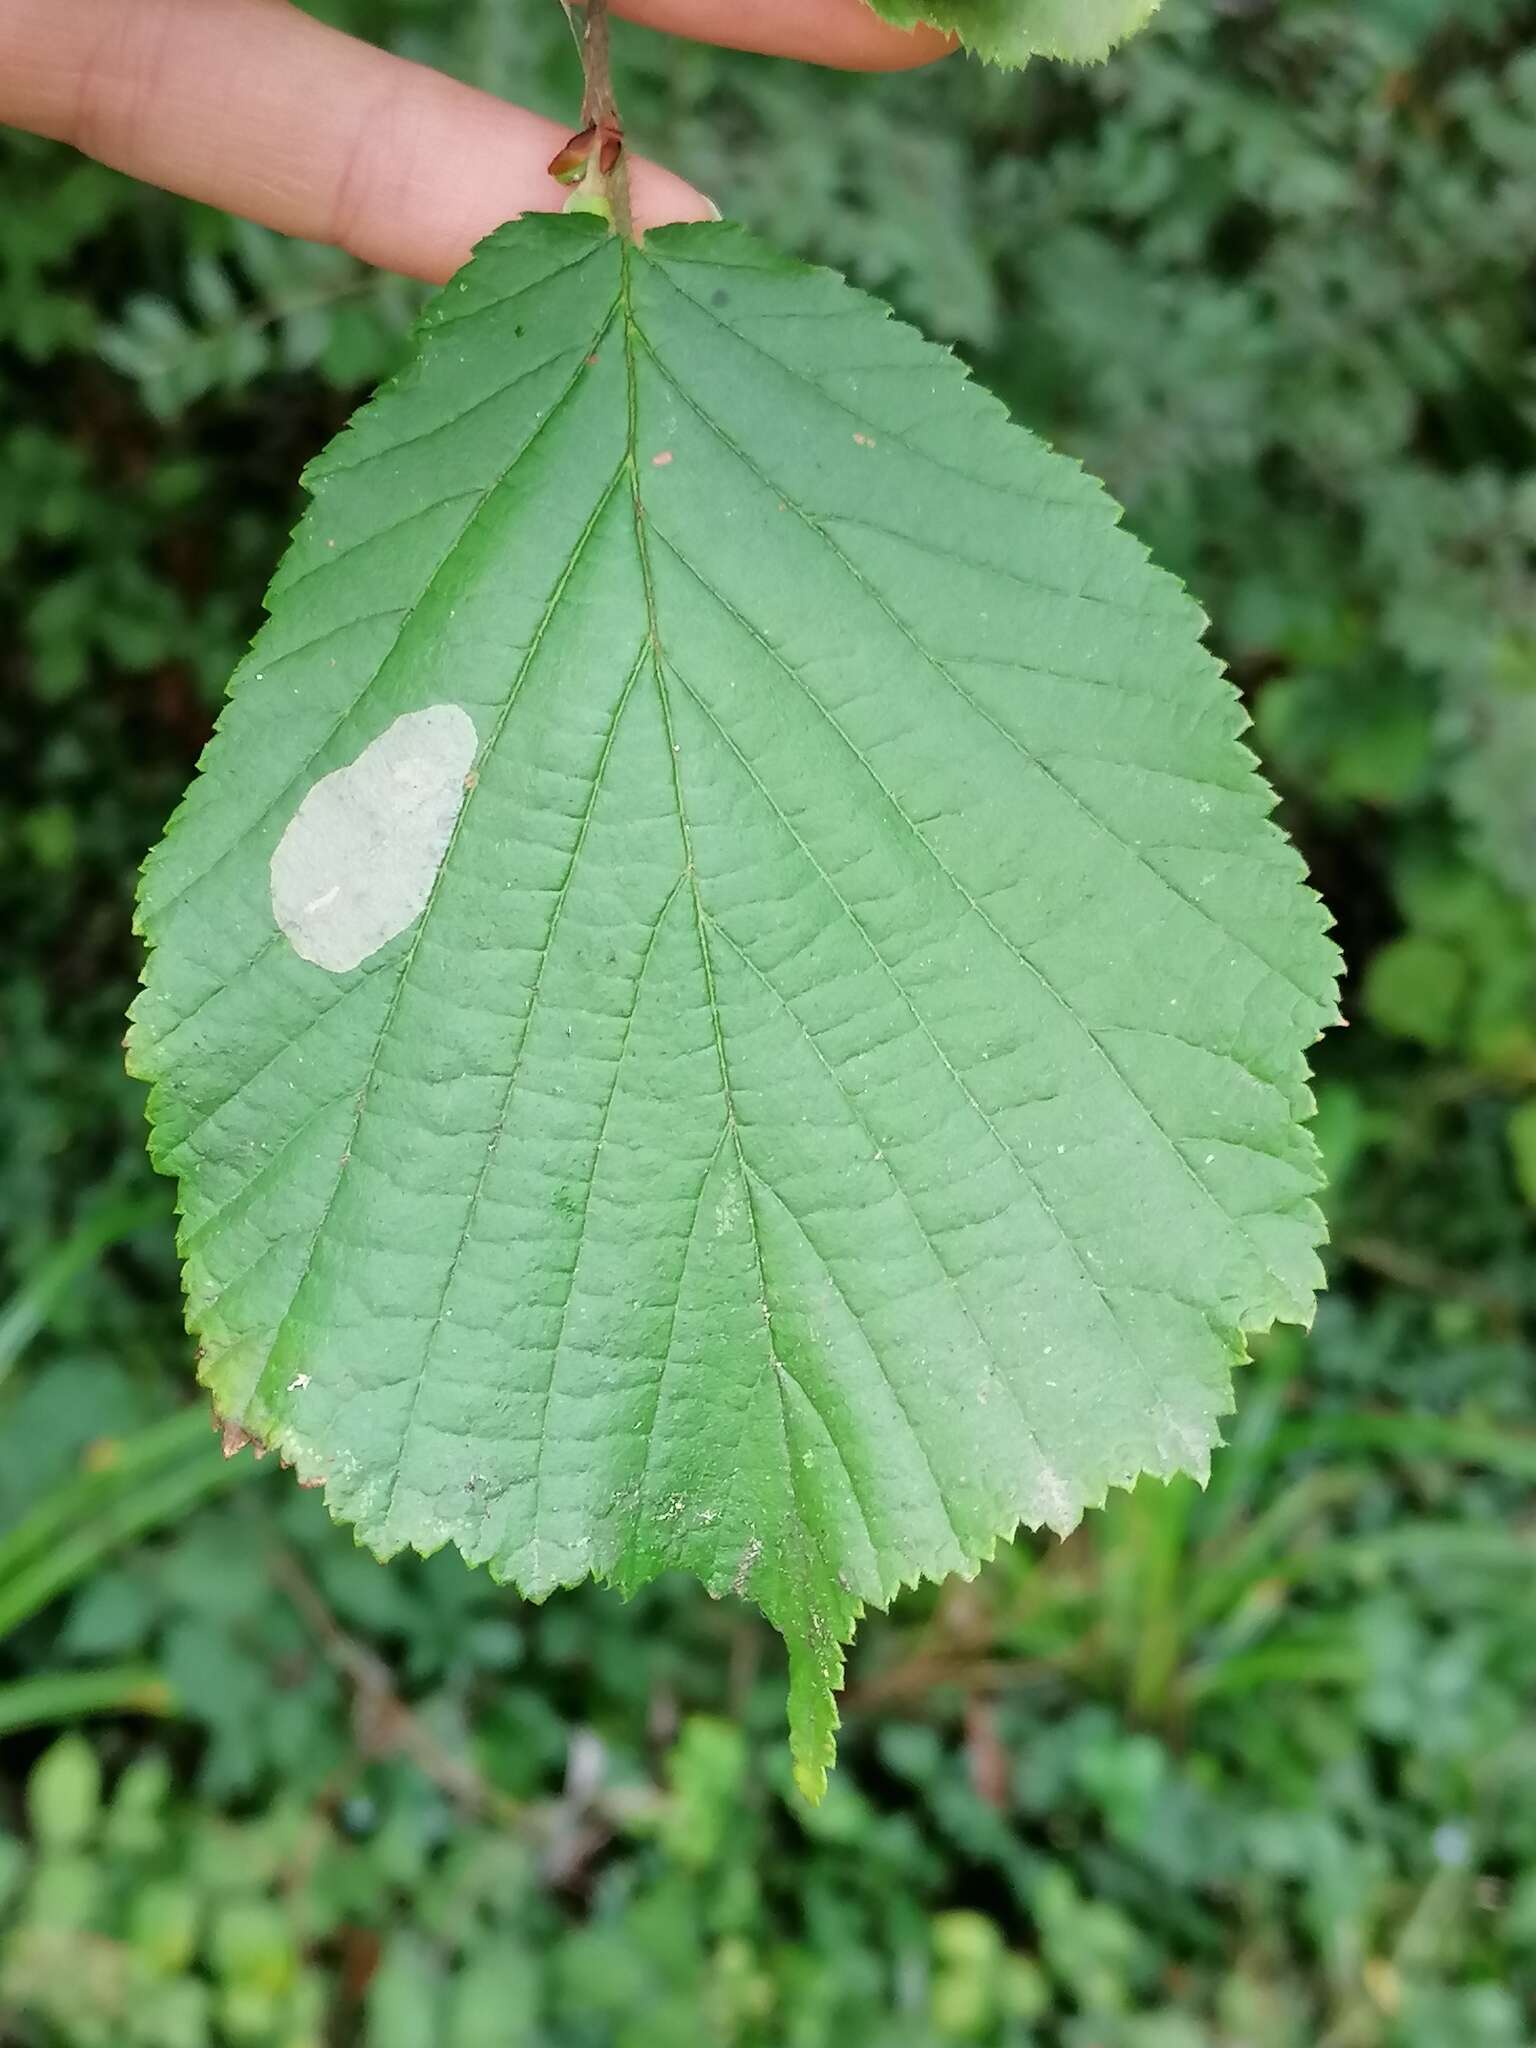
[0,0,716,283]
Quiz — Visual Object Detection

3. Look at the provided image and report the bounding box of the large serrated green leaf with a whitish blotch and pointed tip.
[131,217,1333,1792]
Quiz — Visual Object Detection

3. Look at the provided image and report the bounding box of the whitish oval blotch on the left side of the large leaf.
[272,705,477,975]
